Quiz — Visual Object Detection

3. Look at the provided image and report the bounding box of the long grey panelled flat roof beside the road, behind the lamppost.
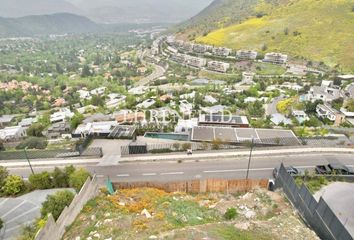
[191,126,301,146]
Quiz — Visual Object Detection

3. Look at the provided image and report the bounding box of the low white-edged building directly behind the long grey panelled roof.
[198,114,249,128]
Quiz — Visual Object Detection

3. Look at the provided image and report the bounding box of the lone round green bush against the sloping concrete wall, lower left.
[41,190,74,220]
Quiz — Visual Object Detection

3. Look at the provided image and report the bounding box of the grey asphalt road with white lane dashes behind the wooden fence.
[9,153,354,182]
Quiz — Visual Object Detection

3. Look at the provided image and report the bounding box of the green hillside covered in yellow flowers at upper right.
[196,0,354,72]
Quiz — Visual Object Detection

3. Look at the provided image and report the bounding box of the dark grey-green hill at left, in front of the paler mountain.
[0,13,102,37]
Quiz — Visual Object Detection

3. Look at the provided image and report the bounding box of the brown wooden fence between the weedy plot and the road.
[114,179,268,193]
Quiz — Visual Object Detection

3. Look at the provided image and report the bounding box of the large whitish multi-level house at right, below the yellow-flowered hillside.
[305,81,342,102]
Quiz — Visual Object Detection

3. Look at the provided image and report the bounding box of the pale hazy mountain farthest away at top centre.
[67,0,212,23]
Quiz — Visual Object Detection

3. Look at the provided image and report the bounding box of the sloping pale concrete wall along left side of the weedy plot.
[35,176,99,240]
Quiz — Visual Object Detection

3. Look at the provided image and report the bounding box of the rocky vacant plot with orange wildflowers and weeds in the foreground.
[63,188,318,240]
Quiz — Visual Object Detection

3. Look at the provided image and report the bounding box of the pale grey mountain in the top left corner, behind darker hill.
[0,0,81,18]
